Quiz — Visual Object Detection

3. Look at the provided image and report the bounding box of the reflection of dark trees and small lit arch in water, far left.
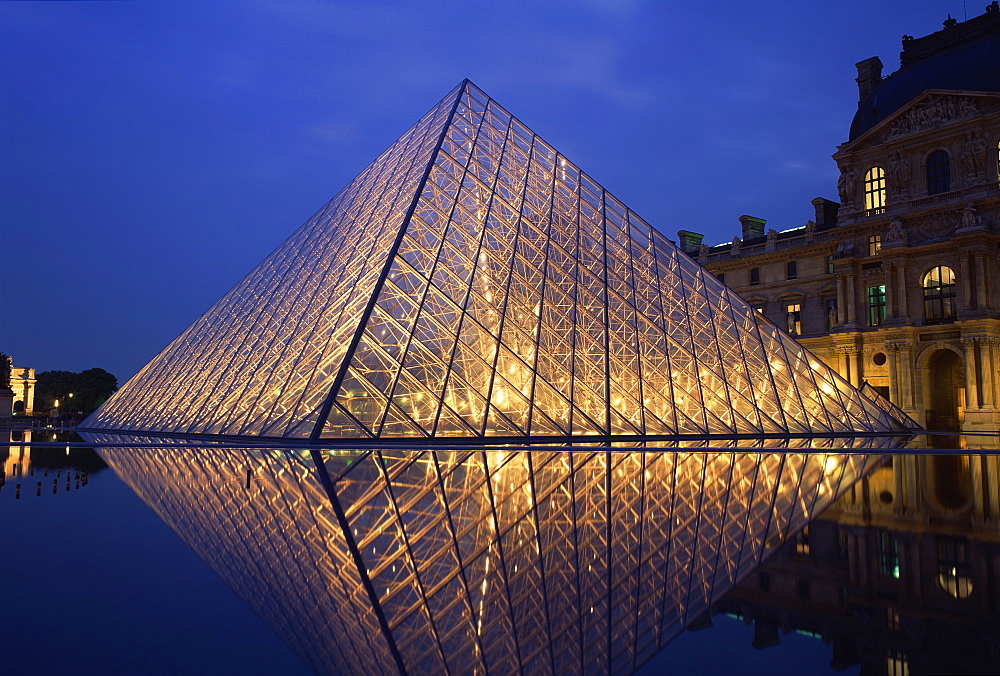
[0,429,107,499]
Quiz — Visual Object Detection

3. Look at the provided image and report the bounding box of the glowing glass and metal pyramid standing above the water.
[84,81,900,440]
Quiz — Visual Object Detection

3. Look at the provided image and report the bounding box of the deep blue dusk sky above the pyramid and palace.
[0,0,968,383]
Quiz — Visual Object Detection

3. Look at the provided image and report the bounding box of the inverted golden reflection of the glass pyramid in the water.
[87,435,896,674]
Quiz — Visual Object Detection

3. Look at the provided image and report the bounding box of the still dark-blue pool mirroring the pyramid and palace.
[0,439,1000,673]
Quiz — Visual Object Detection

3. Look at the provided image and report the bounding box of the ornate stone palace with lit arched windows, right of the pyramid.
[693,7,1000,440]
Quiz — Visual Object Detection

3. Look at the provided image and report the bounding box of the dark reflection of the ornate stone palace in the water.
[716,448,1000,676]
